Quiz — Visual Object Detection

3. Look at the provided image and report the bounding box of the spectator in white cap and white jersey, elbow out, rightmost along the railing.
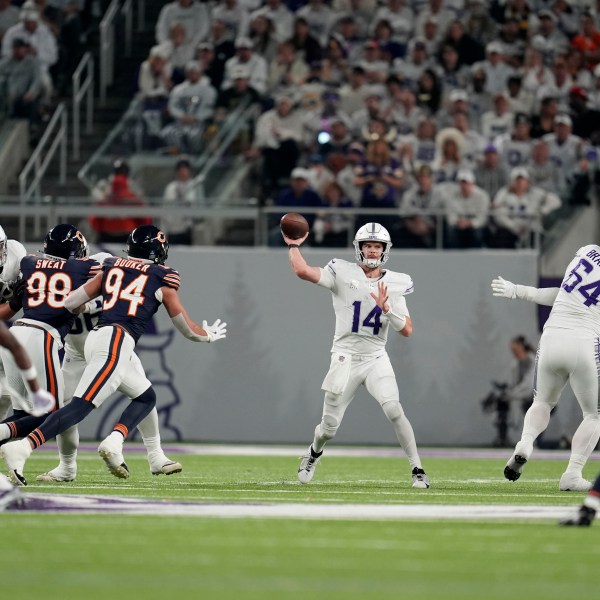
[490,167,561,248]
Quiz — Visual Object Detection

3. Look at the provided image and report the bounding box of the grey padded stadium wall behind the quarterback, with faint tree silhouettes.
[81,247,539,445]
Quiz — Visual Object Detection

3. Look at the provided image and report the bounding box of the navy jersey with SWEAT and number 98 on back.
[21,255,102,338]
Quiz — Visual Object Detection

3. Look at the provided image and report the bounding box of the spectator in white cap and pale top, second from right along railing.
[444,169,490,249]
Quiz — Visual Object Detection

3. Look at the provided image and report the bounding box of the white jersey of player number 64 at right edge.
[544,244,600,337]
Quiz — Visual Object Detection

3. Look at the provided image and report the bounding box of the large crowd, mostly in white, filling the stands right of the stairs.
[125,0,600,248]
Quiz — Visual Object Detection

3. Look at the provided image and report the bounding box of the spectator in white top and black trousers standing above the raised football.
[249,95,302,196]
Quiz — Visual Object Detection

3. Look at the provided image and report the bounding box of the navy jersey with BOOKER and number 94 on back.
[98,256,180,343]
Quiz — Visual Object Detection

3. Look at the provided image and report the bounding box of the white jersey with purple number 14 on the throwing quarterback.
[318,258,414,355]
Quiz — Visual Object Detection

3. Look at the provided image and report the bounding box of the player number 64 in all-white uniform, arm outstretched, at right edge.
[492,244,600,492]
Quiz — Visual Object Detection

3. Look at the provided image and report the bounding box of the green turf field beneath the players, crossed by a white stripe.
[0,452,600,600]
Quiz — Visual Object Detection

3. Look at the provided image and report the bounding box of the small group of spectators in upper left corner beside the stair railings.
[0,0,92,127]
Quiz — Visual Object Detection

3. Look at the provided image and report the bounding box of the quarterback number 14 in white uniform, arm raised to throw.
[283,223,429,488]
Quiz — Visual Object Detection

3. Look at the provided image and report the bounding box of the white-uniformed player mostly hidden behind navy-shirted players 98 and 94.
[36,252,182,481]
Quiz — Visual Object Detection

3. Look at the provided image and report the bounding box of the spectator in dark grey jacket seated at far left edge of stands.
[0,38,42,122]
